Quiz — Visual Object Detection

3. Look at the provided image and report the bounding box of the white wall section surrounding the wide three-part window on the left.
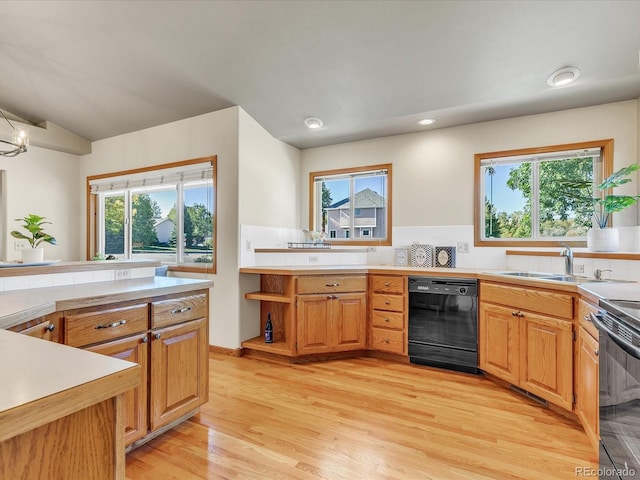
[77,107,240,348]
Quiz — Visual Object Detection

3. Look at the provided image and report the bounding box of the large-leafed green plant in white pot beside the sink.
[563,163,640,252]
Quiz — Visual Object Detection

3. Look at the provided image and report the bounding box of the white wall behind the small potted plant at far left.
[0,146,84,261]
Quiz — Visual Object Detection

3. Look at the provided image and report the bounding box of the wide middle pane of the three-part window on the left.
[131,189,176,263]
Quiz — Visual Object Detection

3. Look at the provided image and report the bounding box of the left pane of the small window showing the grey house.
[315,179,351,239]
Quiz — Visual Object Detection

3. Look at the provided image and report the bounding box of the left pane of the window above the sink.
[483,163,532,238]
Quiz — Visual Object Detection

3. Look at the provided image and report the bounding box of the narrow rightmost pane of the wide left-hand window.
[184,185,213,267]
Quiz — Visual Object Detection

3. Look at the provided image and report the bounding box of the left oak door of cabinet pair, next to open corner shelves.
[296,294,333,355]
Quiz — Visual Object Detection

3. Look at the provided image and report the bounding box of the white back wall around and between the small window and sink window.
[300,100,640,229]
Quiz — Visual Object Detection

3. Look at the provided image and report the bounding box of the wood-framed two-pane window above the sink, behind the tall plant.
[475,140,613,246]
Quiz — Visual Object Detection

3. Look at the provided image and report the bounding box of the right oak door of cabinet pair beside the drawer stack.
[331,293,367,352]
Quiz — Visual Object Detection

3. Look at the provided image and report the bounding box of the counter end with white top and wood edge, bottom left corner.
[0,330,141,480]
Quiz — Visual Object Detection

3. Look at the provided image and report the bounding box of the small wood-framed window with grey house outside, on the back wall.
[309,164,391,245]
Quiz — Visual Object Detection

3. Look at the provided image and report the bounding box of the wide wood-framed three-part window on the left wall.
[87,157,216,273]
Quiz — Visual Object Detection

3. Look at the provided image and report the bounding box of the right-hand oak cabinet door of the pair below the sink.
[520,311,573,410]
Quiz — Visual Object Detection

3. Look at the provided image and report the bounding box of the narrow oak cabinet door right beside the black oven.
[576,327,600,449]
